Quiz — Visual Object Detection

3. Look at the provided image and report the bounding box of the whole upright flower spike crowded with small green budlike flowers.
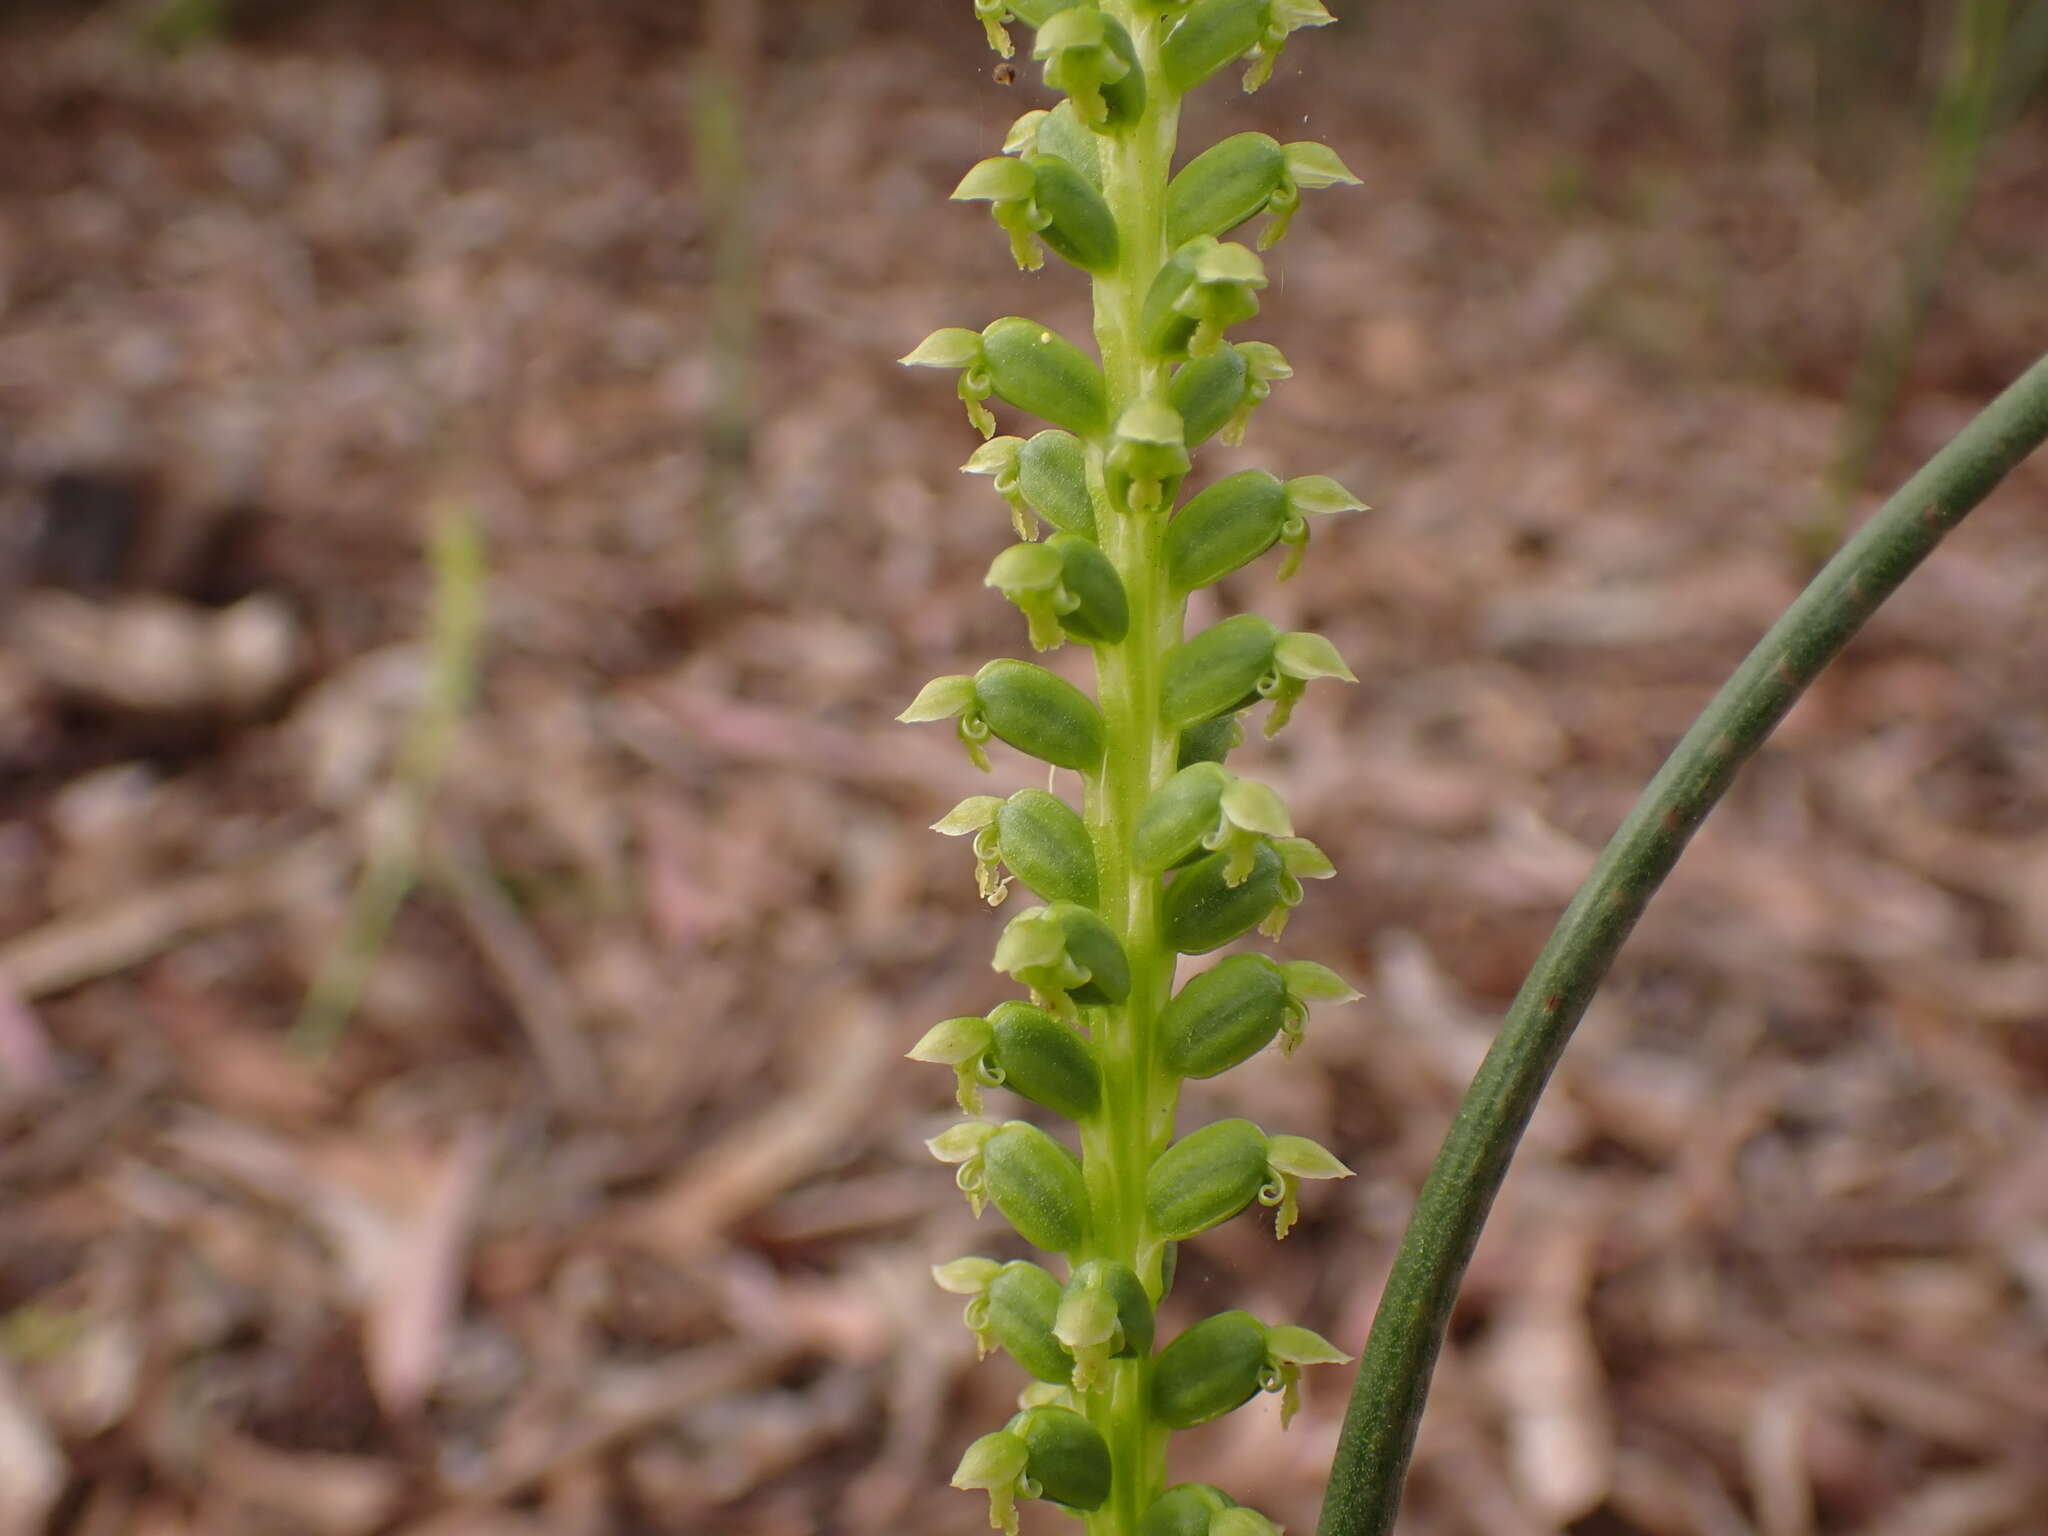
[901,0,1362,1536]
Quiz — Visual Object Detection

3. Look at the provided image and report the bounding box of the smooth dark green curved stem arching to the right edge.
[1319,356,2048,1536]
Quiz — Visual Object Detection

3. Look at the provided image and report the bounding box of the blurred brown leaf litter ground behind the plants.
[0,0,2048,1536]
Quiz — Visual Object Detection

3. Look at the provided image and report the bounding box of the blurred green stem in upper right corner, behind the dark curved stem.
[1800,0,2048,561]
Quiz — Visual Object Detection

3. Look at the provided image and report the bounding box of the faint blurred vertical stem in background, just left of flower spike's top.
[690,0,760,600]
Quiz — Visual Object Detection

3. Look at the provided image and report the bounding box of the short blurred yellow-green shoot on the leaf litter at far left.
[291,504,487,1057]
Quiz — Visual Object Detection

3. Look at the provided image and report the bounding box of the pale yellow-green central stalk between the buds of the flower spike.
[1081,0,1184,1536]
